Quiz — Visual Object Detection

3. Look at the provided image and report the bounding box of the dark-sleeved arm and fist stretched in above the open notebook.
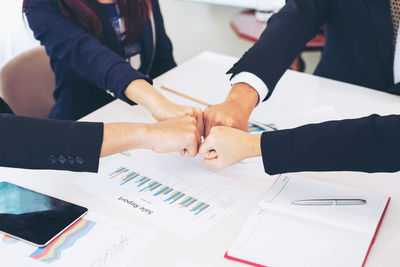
[199,115,400,174]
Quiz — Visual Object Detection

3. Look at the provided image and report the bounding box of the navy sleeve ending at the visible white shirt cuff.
[228,0,331,98]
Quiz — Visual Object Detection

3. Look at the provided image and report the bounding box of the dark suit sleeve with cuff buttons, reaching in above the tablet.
[0,114,103,172]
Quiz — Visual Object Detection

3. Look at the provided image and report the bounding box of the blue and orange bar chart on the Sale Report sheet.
[108,167,210,215]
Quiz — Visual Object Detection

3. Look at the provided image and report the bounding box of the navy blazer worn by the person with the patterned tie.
[228,0,400,98]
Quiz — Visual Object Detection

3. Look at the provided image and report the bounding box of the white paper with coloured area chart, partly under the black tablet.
[0,213,155,267]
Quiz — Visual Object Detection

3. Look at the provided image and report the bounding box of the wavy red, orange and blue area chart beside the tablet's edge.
[30,219,96,263]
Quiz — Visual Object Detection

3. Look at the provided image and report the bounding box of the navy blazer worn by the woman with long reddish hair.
[25,0,176,120]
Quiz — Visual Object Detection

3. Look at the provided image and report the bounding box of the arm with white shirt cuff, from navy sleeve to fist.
[205,0,331,135]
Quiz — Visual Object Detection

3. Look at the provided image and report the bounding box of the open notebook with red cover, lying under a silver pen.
[225,175,390,267]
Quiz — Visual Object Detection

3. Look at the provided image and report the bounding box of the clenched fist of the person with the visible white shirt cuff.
[204,83,258,137]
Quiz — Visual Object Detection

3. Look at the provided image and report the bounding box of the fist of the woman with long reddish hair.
[150,100,204,135]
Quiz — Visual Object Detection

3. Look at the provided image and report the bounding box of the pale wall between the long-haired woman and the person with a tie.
[159,0,252,64]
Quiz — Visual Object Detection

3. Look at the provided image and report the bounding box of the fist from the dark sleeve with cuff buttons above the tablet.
[145,116,201,157]
